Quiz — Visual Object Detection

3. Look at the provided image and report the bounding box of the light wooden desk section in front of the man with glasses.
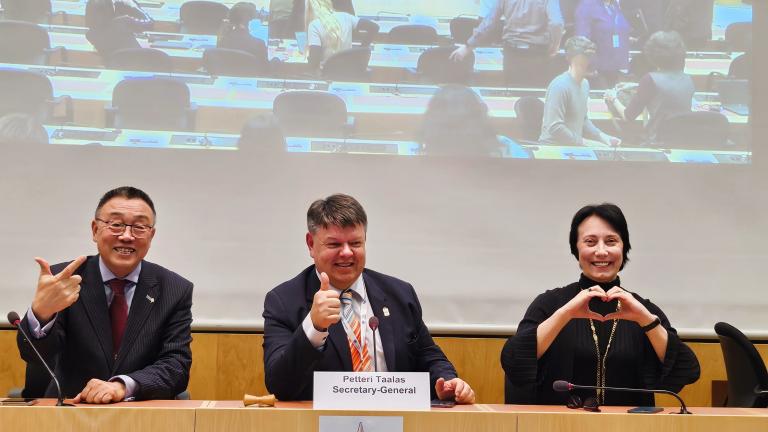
[0,399,201,432]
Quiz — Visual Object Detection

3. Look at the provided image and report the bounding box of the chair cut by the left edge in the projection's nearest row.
[0,68,73,124]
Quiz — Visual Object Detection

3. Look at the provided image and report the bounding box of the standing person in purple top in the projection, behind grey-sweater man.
[575,0,630,89]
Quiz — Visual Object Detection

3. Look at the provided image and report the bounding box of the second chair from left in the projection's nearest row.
[105,76,197,131]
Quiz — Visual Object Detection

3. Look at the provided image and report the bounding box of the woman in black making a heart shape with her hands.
[501,204,699,406]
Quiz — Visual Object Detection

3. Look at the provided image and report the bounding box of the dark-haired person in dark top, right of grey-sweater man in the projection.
[605,32,696,144]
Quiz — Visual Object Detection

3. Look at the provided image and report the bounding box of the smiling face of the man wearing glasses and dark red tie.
[91,197,155,277]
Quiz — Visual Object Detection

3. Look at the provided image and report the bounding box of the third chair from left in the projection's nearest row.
[272,90,354,138]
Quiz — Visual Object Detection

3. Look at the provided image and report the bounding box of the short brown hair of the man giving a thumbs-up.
[307,194,368,234]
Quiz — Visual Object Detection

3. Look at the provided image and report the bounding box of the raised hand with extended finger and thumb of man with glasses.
[32,256,85,324]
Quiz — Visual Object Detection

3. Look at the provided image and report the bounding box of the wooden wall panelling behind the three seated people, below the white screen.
[0,330,768,406]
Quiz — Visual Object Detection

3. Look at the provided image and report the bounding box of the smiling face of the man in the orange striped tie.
[306,224,365,289]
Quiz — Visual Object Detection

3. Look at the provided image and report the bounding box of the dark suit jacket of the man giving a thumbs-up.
[264,265,456,400]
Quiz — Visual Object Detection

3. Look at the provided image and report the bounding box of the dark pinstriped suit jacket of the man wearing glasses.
[17,256,192,399]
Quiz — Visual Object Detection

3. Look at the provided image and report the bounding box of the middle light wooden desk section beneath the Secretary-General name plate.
[195,401,517,432]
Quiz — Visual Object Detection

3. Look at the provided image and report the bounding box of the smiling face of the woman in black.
[576,215,624,282]
